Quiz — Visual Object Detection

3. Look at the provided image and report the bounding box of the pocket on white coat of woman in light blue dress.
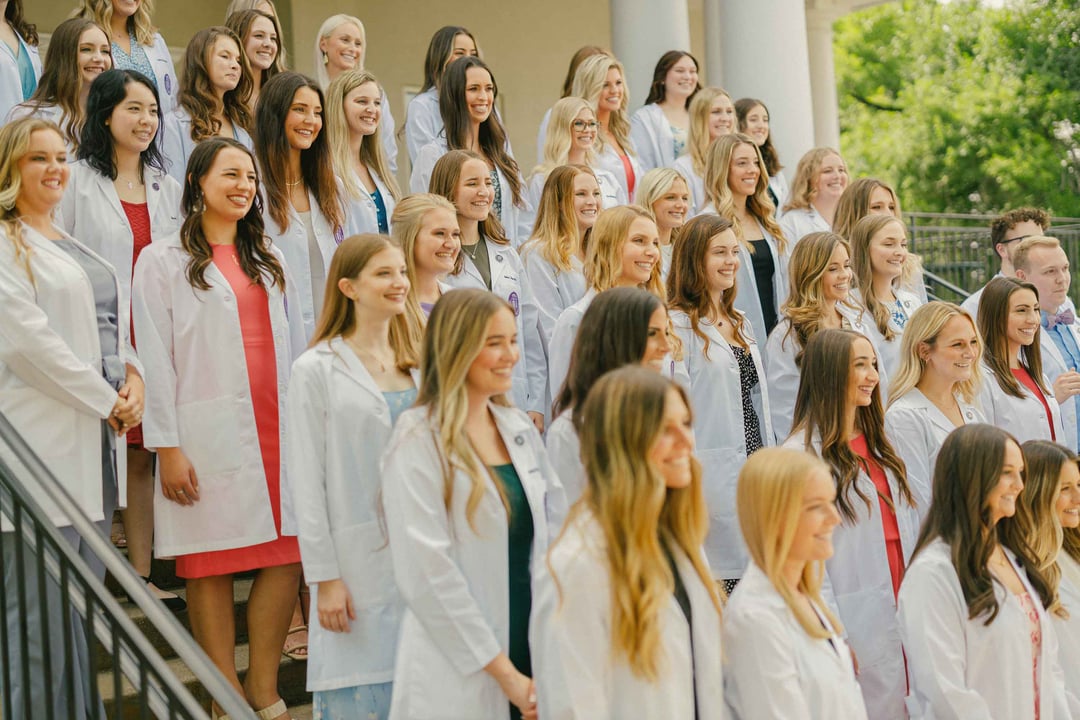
[332,520,399,610]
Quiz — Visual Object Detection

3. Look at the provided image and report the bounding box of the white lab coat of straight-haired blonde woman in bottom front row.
[723,562,866,720]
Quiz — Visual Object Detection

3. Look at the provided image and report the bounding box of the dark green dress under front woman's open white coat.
[491,464,534,720]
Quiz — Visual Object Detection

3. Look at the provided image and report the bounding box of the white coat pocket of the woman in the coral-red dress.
[176,397,243,479]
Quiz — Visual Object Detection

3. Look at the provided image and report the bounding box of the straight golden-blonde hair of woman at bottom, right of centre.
[735,448,843,639]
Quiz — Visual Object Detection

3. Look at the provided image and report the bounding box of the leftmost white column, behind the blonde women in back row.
[611,0,690,112]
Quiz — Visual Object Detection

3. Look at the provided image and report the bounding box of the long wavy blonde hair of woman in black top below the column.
[702,133,787,255]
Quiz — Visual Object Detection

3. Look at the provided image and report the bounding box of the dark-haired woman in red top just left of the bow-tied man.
[978,277,1065,443]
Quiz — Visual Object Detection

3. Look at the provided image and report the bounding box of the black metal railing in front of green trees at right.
[904,213,1080,302]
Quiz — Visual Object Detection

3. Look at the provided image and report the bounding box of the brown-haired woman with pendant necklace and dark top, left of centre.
[431,150,548,432]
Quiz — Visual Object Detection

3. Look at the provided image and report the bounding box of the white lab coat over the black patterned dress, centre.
[671,310,775,579]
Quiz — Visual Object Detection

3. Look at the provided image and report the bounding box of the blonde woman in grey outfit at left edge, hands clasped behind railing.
[0,119,143,720]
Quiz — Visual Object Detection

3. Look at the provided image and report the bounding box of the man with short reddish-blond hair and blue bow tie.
[1013,235,1080,452]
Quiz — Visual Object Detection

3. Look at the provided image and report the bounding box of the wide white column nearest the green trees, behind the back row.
[721,0,814,178]
